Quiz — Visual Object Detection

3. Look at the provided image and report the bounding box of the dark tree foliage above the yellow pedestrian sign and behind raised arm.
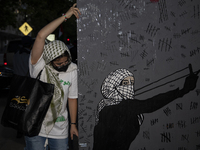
[0,0,76,42]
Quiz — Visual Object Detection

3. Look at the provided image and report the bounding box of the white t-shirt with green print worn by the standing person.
[29,56,78,139]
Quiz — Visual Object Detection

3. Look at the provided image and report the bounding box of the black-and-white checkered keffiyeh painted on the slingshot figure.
[96,69,143,124]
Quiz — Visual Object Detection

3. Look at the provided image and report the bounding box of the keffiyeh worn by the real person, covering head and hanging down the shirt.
[43,40,71,134]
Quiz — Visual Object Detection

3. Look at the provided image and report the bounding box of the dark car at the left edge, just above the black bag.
[0,66,14,89]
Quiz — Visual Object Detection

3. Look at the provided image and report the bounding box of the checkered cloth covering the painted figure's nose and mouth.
[116,85,134,99]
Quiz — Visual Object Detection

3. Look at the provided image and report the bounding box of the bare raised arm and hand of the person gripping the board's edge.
[31,4,80,64]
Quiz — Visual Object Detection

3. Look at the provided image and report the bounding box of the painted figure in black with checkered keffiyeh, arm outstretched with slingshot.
[93,65,198,150]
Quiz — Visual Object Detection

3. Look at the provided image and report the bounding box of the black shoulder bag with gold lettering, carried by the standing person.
[1,70,54,137]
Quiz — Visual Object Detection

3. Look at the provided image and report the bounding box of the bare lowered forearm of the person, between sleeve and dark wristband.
[68,98,77,123]
